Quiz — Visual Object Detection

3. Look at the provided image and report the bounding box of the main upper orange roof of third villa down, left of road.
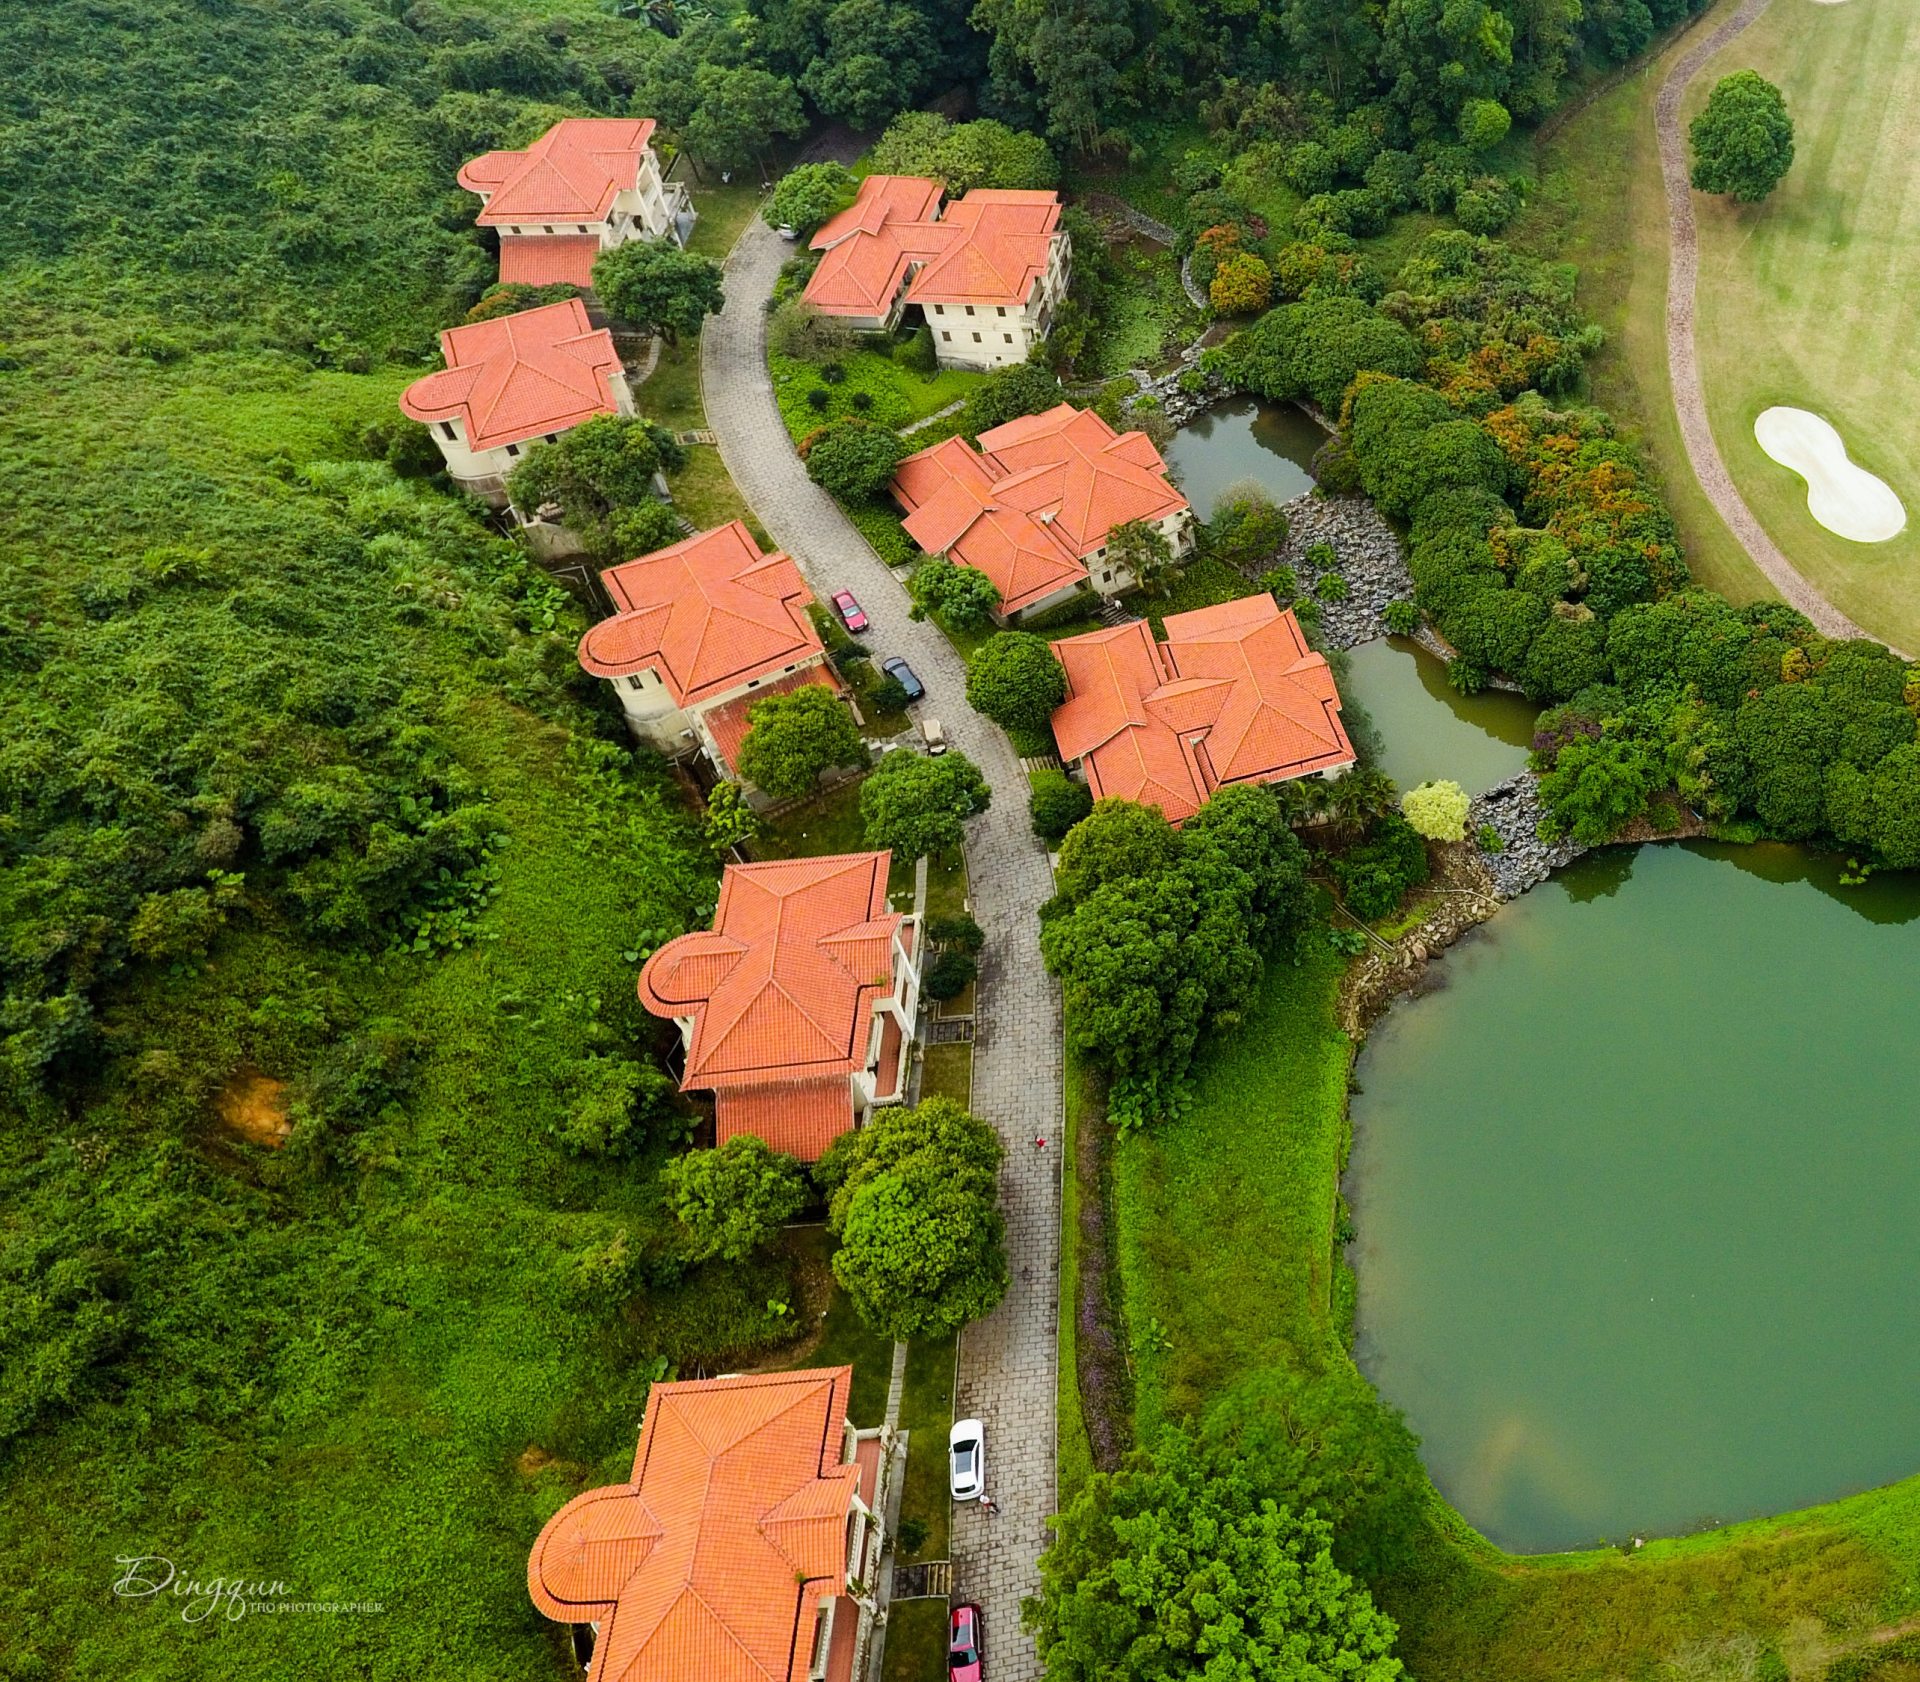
[580,520,826,710]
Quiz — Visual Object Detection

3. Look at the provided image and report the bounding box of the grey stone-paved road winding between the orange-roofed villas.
[701,221,1062,1682]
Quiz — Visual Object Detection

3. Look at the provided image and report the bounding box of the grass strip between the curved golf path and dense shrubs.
[1507,0,1758,601]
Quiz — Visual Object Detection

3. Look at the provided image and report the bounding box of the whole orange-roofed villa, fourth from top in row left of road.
[639,853,920,1162]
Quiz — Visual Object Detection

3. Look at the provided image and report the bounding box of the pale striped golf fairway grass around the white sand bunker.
[1686,0,1920,649]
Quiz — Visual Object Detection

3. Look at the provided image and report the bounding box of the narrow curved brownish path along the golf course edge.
[1653,0,1870,637]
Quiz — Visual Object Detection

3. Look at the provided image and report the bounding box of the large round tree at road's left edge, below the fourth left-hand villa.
[814,1098,1008,1340]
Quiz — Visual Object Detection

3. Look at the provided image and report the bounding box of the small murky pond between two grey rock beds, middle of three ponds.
[1340,637,1540,795]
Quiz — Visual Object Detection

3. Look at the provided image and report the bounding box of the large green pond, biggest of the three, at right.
[1348,845,1920,1551]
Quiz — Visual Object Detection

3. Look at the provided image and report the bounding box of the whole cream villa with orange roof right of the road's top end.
[806,175,1073,369]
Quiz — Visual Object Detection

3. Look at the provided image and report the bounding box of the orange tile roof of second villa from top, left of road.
[399,298,620,449]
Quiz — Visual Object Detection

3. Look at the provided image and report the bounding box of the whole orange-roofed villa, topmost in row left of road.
[459,117,693,288]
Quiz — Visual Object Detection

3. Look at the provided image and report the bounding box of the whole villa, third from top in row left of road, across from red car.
[580,520,845,778]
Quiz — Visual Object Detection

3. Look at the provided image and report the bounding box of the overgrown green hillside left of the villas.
[0,0,793,1682]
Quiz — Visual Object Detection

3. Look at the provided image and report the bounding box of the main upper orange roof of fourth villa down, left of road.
[639,853,902,1091]
